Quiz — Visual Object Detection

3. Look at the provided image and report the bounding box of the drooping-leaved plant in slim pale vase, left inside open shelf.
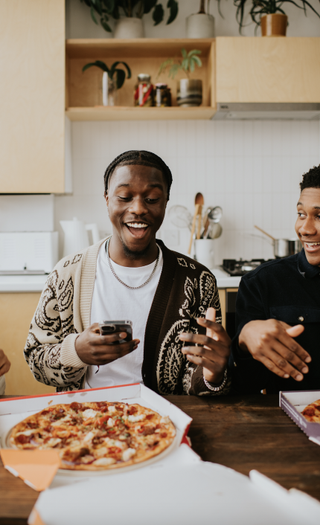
[82,60,131,106]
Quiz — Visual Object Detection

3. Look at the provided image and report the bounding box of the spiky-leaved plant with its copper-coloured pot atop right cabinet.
[233,0,320,36]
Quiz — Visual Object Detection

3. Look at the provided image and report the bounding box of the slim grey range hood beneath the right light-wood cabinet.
[212,102,320,120]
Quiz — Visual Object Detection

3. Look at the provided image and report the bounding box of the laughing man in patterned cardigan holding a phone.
[25,151,230,395]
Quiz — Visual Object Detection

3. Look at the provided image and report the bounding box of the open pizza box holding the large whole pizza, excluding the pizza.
[0,383,192,490]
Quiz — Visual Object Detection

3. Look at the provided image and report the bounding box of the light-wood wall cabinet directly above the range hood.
[216,37,320,104]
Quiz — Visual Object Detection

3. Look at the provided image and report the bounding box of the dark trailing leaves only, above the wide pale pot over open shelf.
[80,0,178,32]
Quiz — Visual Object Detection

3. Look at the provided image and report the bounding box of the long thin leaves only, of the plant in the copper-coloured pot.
[233,0,320,33]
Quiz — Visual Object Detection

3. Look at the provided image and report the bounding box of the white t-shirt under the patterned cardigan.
[84,244,163,388]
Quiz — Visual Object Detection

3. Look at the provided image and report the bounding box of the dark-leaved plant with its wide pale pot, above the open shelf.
[80,0,178,38]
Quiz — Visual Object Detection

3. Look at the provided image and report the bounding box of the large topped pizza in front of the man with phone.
[8,401,175,470]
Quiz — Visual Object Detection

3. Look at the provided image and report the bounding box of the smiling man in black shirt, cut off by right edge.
[232,166,320,393]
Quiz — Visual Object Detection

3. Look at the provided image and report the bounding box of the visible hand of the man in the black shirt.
[239,319,311,381]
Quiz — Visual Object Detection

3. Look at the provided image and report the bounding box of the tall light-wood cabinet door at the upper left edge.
[0,0,66,193]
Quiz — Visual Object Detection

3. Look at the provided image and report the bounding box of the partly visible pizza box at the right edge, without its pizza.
[279,390,320,445]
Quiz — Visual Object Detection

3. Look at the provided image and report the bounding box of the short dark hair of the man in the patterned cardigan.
[104,150,172,200]
